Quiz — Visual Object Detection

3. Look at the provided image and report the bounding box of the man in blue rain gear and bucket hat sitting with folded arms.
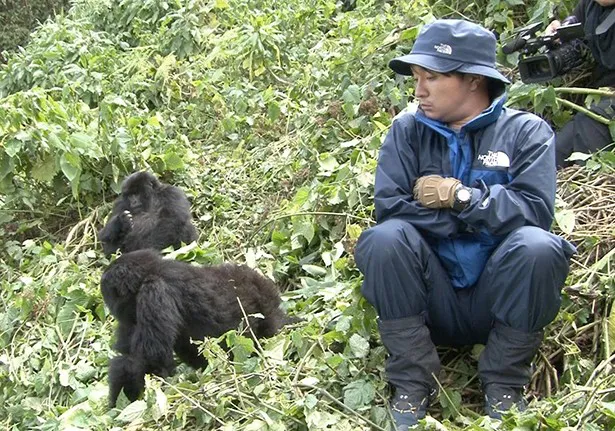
[355,20,575,430]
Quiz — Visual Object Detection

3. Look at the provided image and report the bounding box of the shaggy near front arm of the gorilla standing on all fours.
[130,278,184,377]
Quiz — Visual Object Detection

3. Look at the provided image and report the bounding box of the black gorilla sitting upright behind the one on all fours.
[98,172,198,256]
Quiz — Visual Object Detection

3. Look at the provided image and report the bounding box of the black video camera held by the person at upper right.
[502,23,585,84]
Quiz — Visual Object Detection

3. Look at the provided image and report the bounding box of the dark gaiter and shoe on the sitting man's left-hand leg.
[378,316,440,431]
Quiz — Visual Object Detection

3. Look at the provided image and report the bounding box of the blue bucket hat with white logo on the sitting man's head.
[389,19,510,84]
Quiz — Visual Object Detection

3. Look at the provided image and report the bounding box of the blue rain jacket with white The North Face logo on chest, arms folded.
[374,95,555,289]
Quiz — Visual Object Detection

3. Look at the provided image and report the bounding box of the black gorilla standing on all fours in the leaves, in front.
[101,250,296,407]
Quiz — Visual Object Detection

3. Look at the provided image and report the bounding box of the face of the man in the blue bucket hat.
[412,66,476,123]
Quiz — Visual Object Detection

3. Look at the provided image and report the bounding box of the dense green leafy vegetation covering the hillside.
[0,0,615,430]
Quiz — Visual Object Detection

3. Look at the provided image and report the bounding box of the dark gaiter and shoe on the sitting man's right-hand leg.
[478,323,543,419]
